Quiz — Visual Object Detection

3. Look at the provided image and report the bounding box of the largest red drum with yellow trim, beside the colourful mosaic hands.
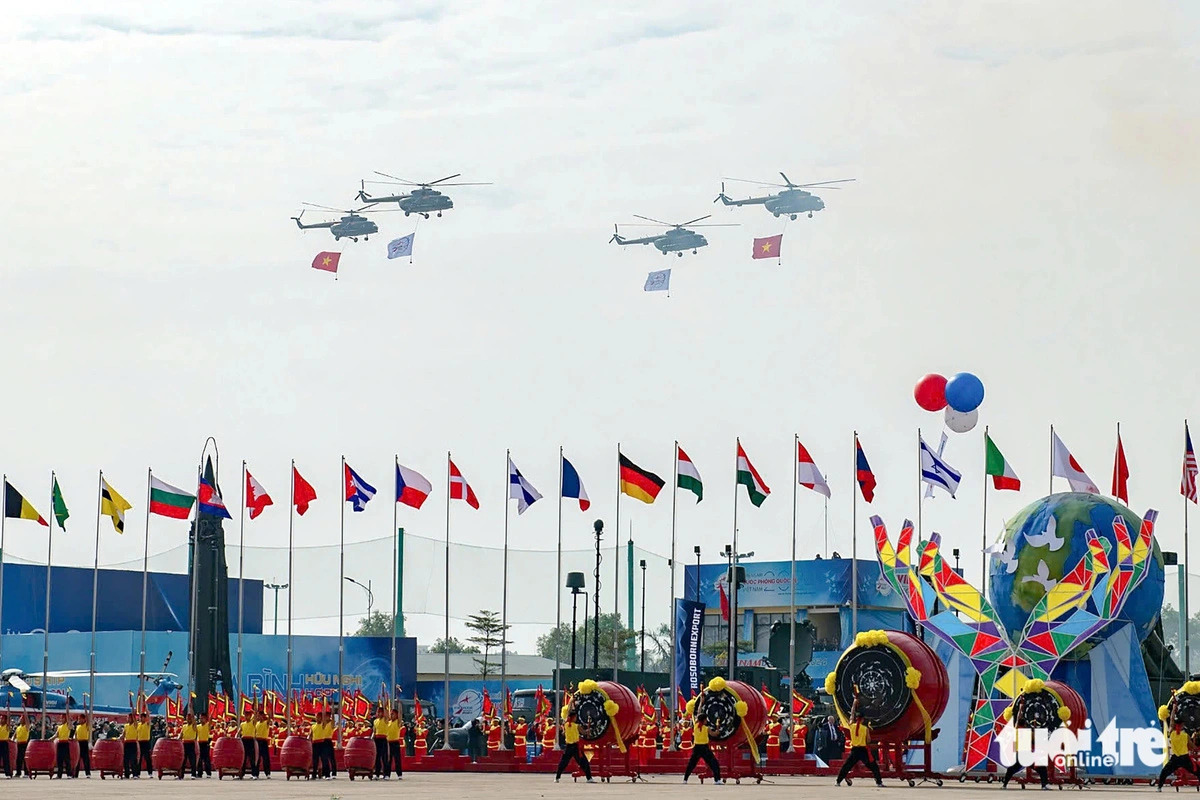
[826,631,950,741]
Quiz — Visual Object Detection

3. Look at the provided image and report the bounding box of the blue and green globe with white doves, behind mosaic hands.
[988,492,1164,642]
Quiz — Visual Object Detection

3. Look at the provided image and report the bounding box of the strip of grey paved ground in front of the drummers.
[0,772,1161,800]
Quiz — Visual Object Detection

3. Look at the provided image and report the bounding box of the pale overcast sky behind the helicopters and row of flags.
[0,0,1200,646]
